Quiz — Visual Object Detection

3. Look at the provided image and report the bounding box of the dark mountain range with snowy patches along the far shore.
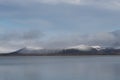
[0,45,120,56]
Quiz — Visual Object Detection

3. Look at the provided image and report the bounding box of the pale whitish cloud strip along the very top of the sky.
[0,0,120,9]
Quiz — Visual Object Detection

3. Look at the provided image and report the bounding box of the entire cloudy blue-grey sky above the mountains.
[0,0,120,52]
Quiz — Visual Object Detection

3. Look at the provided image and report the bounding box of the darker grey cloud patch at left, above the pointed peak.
[0,29,44,41]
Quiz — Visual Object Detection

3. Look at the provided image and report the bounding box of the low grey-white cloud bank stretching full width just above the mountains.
[0,30,120,52]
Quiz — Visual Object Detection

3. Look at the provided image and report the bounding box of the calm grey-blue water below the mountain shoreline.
[0,56,120,80]
